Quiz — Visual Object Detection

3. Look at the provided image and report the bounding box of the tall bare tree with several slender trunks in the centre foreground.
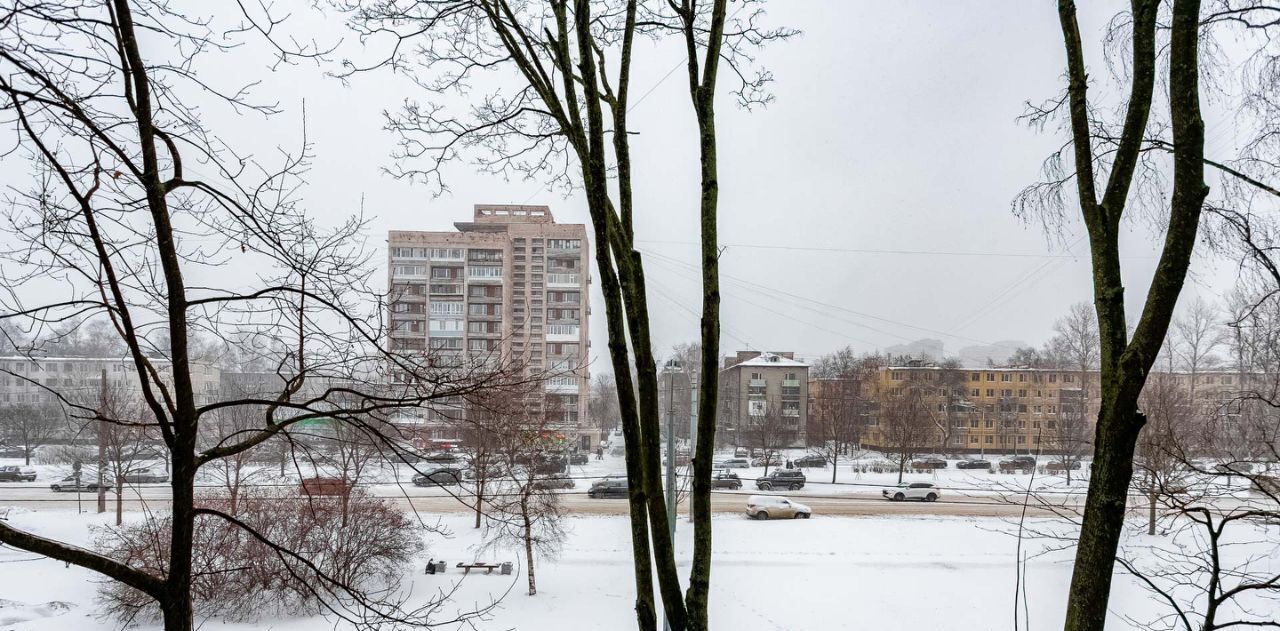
[339,0,791,631]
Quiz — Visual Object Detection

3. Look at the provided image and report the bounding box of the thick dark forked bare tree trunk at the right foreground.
[1015,0,1208,631]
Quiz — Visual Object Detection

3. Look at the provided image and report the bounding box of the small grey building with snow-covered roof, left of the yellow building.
[716,351,809,449]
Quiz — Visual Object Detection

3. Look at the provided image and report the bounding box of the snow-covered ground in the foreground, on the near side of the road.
[0,511,1239,631]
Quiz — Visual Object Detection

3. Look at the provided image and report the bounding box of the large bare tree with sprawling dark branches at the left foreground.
[0,0,524,631]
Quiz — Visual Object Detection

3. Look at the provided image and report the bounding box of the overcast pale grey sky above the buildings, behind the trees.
[180,0,1229,370]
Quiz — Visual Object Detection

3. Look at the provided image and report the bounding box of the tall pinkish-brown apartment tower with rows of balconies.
[387,205,600,449]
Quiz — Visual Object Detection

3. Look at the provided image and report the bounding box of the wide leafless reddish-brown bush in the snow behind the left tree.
[96,488,422,625]
